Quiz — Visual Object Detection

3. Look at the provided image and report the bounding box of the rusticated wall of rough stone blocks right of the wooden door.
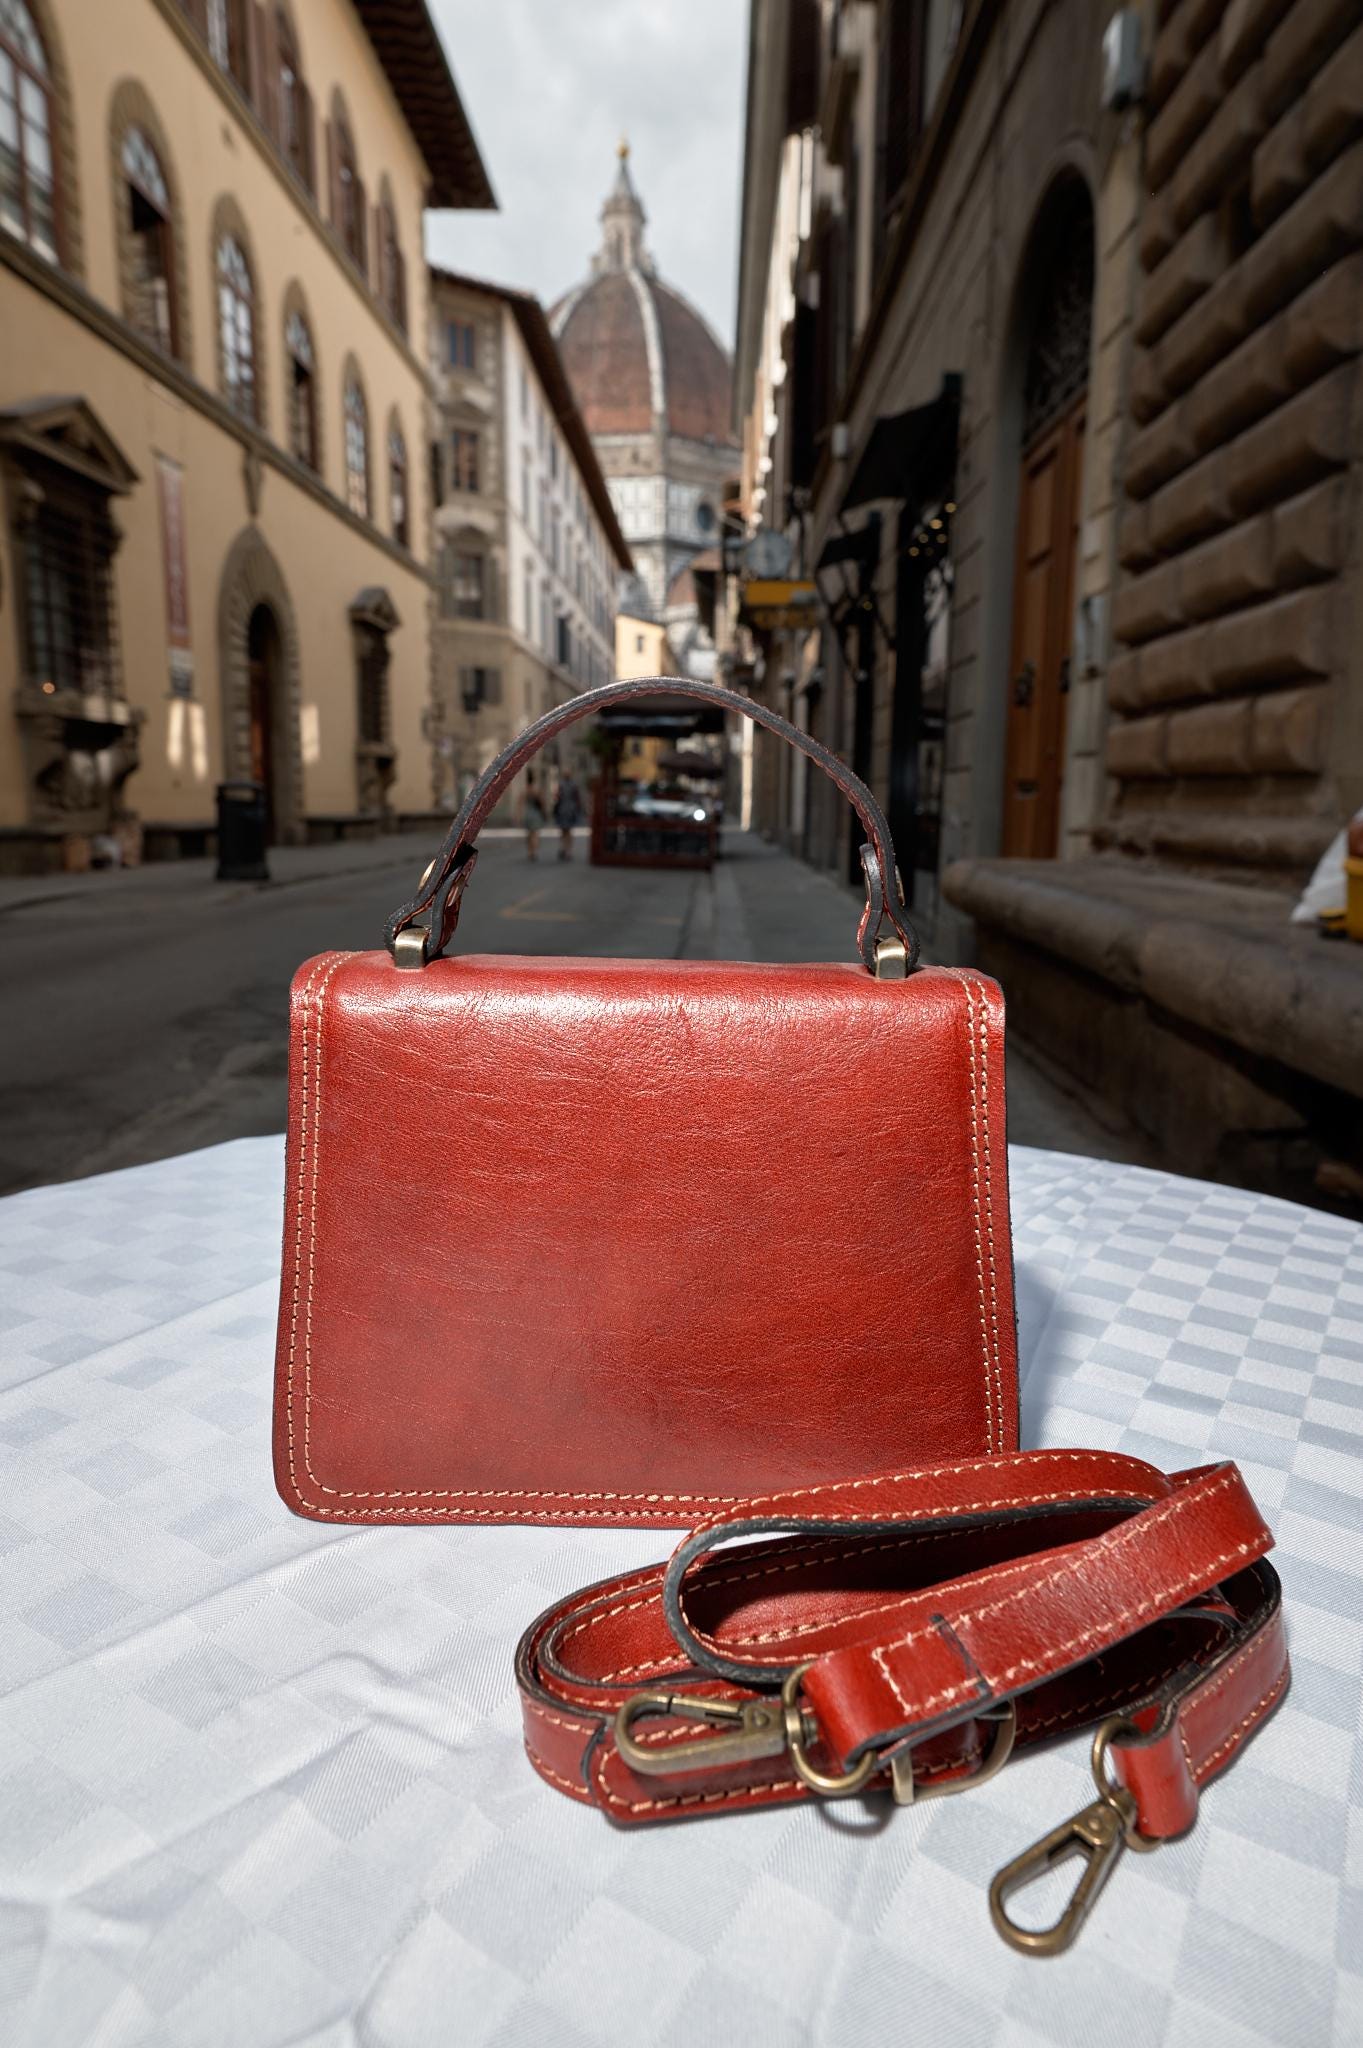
[1097,0,1363,887]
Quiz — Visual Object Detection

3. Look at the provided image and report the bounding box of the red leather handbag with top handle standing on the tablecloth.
[274,678,1017,1526]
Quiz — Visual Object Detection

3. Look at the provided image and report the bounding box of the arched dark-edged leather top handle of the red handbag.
[383,676,919,975]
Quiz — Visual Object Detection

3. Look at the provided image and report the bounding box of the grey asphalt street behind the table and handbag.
[0,831,1144,1192]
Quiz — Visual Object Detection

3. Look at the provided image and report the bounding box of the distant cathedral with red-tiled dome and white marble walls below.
[551,143,737,676]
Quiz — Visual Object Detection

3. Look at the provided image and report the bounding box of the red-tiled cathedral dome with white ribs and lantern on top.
[548,145,733,442]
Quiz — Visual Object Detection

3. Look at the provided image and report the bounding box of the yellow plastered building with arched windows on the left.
[0,0,491,866]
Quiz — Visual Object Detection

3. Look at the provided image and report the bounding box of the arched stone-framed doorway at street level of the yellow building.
[217,526,307,846]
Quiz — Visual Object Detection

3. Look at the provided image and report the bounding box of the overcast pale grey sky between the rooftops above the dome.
[426,0,747,346]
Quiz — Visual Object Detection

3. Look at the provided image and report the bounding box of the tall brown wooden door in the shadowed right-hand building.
[1003,395,1085,860]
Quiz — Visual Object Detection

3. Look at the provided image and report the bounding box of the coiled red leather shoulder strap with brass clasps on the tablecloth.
[518,1450,1287,1950]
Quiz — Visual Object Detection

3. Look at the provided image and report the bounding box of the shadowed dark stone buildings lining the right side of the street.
[727,0,1363,1200]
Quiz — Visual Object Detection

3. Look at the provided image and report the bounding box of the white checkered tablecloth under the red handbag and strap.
[0,1139,1363,2048]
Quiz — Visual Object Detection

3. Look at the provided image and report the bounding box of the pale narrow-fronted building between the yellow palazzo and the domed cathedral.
[430,270,632,811]
